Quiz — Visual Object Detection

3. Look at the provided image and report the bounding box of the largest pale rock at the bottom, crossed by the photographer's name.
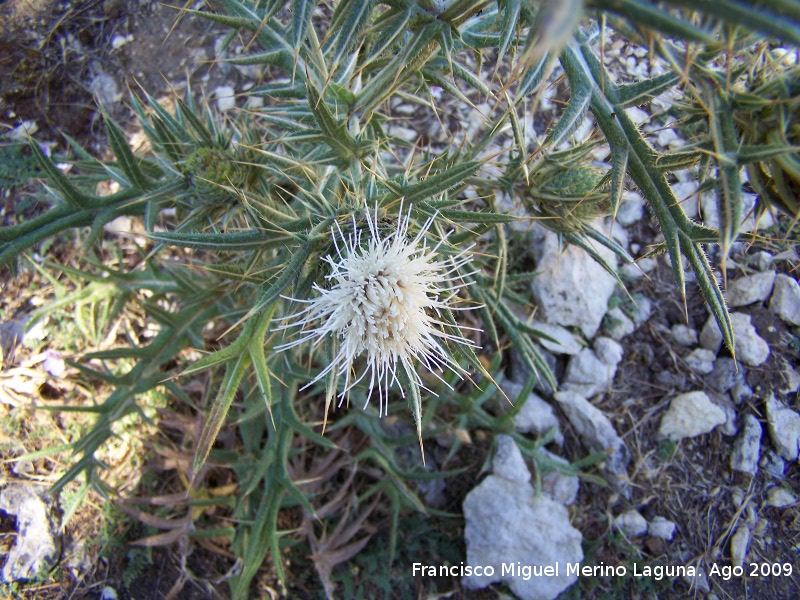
[463,438,583,600]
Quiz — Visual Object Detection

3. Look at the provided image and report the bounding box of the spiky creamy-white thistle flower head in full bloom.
[275,204,477,426]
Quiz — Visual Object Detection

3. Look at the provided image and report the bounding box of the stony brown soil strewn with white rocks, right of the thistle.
[456,200,800,599]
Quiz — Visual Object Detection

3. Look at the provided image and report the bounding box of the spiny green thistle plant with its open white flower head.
[0,0,800,598]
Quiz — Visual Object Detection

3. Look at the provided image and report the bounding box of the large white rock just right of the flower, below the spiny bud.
[531,227,617,338]
